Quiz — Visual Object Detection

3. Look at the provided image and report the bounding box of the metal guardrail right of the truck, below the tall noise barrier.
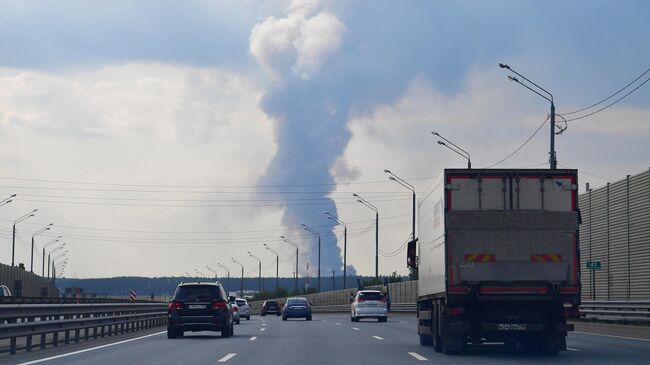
[580,301,650,323]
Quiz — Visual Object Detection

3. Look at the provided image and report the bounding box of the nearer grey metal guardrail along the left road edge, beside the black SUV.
[0,303,167,354]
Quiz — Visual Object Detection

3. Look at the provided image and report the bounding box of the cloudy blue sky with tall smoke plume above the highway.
[0,0,650,277]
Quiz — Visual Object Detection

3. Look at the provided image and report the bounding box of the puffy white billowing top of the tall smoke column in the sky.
[249,1,344,80]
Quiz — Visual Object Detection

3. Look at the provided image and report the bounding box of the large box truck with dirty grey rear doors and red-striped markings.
[407,169,580,354]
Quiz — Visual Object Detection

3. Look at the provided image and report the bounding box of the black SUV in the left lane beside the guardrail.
[167,282,234,338]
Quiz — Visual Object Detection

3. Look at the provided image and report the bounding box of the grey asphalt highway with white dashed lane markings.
[0,314,650,365]
